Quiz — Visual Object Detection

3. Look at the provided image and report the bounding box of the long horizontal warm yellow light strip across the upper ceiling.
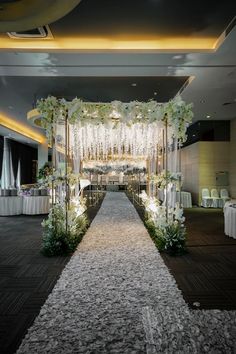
[0,37,218,51]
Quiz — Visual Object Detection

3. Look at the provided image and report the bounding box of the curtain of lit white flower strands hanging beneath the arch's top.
[70,123,162,160]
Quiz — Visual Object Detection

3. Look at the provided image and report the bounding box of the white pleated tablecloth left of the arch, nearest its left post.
[23,196,50,215]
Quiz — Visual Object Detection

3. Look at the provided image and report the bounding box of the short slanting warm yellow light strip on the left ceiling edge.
[0,113,46,144]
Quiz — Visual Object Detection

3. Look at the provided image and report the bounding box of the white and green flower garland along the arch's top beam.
[37,96,193,142]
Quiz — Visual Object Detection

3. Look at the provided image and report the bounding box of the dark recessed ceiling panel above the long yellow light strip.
[50,0,236,39]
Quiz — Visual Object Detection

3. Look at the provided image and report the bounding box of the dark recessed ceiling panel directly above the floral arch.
[0,76,188,102]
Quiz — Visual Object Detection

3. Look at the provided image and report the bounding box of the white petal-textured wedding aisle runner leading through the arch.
[18,192,236,354]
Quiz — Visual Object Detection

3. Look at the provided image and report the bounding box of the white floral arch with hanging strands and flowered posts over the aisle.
[37,96,193,254]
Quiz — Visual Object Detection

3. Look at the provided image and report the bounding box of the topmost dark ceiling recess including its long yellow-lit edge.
[0,0,236,50]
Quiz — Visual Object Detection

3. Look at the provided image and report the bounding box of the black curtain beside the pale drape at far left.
[9,140,38,184]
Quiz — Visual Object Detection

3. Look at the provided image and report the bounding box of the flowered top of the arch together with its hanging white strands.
[37,96,193,160]
